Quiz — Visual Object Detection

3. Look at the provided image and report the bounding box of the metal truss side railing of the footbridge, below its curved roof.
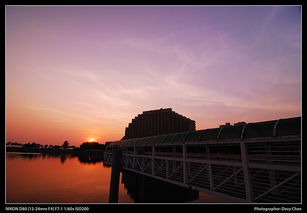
[104,135,301,203]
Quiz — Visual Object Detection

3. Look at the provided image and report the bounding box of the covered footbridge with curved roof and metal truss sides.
[104,117,301,203]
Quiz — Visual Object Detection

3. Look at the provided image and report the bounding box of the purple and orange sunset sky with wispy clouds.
[6,6,302,146]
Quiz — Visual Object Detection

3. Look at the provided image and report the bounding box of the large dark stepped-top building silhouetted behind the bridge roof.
[122,108,195,140]
